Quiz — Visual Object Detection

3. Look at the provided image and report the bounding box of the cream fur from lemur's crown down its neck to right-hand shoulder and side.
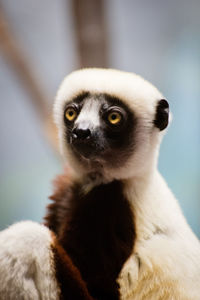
[54,69,200,300]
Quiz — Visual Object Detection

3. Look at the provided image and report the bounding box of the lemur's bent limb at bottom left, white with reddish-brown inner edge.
[0,221,92,300]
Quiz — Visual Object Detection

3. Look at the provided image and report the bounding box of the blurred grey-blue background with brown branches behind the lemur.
[0,0,200,237]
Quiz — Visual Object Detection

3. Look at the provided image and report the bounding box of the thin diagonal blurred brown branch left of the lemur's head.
[0,6,57,148]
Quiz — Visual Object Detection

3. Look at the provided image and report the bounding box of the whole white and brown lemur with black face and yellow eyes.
[0,68,200,300]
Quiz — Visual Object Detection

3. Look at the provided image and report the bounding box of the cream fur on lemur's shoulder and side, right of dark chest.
[118,169,200,300]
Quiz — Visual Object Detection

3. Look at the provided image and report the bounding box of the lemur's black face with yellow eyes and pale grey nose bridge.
[64,93,136,167]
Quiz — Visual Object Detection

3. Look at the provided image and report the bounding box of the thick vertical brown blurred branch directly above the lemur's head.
[71,0,108,67]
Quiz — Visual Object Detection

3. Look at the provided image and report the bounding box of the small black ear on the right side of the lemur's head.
[154,99,169,130]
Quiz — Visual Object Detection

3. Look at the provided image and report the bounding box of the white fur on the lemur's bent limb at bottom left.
[0,221,60,300]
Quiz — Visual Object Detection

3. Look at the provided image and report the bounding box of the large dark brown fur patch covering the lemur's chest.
[45,170,135,300]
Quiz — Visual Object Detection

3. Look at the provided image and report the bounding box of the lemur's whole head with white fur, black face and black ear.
[54,68,168,180]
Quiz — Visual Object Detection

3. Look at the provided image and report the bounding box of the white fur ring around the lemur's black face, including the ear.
[54,68,168,179]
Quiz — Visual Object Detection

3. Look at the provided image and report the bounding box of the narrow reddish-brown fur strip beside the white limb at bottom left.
[51,235,93,300]
